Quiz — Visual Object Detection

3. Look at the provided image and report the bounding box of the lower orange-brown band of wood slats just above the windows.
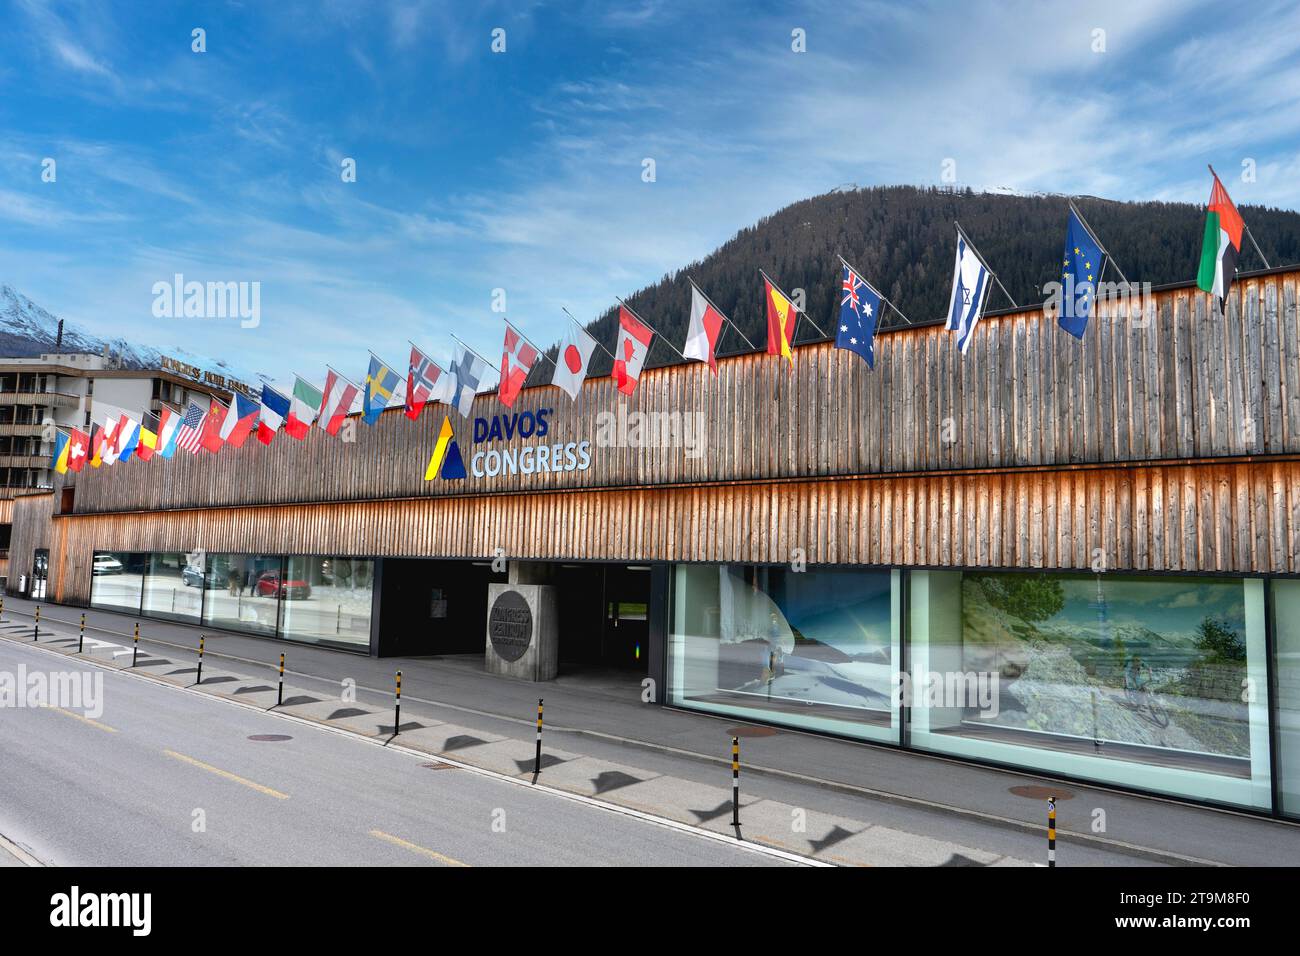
[38,460,1300,601]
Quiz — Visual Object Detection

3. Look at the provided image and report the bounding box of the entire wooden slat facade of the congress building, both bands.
[10,269,1300,602]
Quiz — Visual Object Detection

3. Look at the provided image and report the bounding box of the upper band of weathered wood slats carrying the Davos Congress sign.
[68,271,1300,512]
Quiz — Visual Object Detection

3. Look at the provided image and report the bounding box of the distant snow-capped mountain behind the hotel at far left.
[0,284,267,385]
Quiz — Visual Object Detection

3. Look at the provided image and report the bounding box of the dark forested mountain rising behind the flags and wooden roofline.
[548,185,1300,381]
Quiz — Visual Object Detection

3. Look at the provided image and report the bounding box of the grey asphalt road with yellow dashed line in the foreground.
[0,641,784,866]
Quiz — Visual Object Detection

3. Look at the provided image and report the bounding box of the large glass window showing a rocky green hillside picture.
[909,571,1270,808]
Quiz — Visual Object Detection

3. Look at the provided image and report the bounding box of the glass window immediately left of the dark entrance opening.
[278,557,374,650]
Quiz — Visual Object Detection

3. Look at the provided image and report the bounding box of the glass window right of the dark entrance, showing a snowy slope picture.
[668,564,901,743]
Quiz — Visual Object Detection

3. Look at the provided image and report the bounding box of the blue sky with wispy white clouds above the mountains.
[0,0,1300,390]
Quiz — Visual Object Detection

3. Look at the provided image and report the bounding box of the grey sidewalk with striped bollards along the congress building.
[0,597,1300,865]
